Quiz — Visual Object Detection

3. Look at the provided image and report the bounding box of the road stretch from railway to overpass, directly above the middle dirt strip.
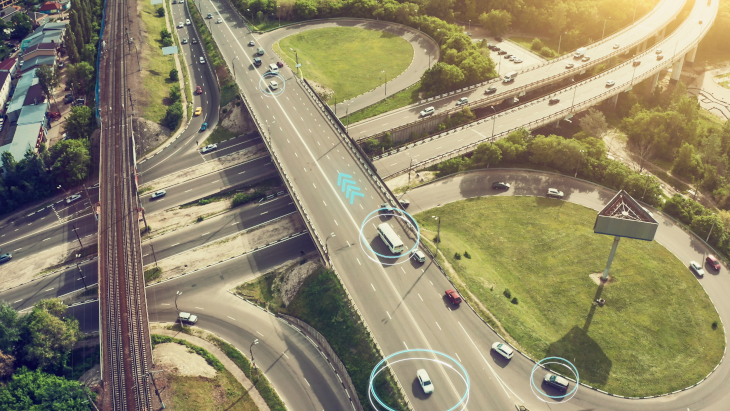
[140,157,276,214]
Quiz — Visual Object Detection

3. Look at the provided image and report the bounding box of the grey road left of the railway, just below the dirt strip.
[0,259,98,311]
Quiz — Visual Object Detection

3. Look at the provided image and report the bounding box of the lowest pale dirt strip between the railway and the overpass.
[148,214,306,282]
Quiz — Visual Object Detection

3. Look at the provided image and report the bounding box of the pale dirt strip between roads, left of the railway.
[0,234,97,290]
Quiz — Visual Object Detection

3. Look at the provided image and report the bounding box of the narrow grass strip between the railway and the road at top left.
[140,2,176,123]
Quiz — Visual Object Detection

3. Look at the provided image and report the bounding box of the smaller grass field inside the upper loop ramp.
[277,27,413,103]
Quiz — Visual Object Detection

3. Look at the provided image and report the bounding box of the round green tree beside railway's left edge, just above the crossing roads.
[51,140,91,187]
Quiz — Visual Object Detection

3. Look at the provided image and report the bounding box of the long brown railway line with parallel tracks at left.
[99,0,152,411]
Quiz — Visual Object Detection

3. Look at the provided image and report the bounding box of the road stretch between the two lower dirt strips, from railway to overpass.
[142,196,297,264]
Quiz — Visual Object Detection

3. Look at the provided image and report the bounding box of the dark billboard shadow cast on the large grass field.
[545,284,613,385]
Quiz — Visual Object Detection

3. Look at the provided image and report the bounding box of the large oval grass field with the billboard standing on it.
[416,197,725,396]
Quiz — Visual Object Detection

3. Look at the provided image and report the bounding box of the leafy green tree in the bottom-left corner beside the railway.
[0,367,91,411]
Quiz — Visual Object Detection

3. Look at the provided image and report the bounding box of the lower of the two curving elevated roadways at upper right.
[373,1,718,179]
